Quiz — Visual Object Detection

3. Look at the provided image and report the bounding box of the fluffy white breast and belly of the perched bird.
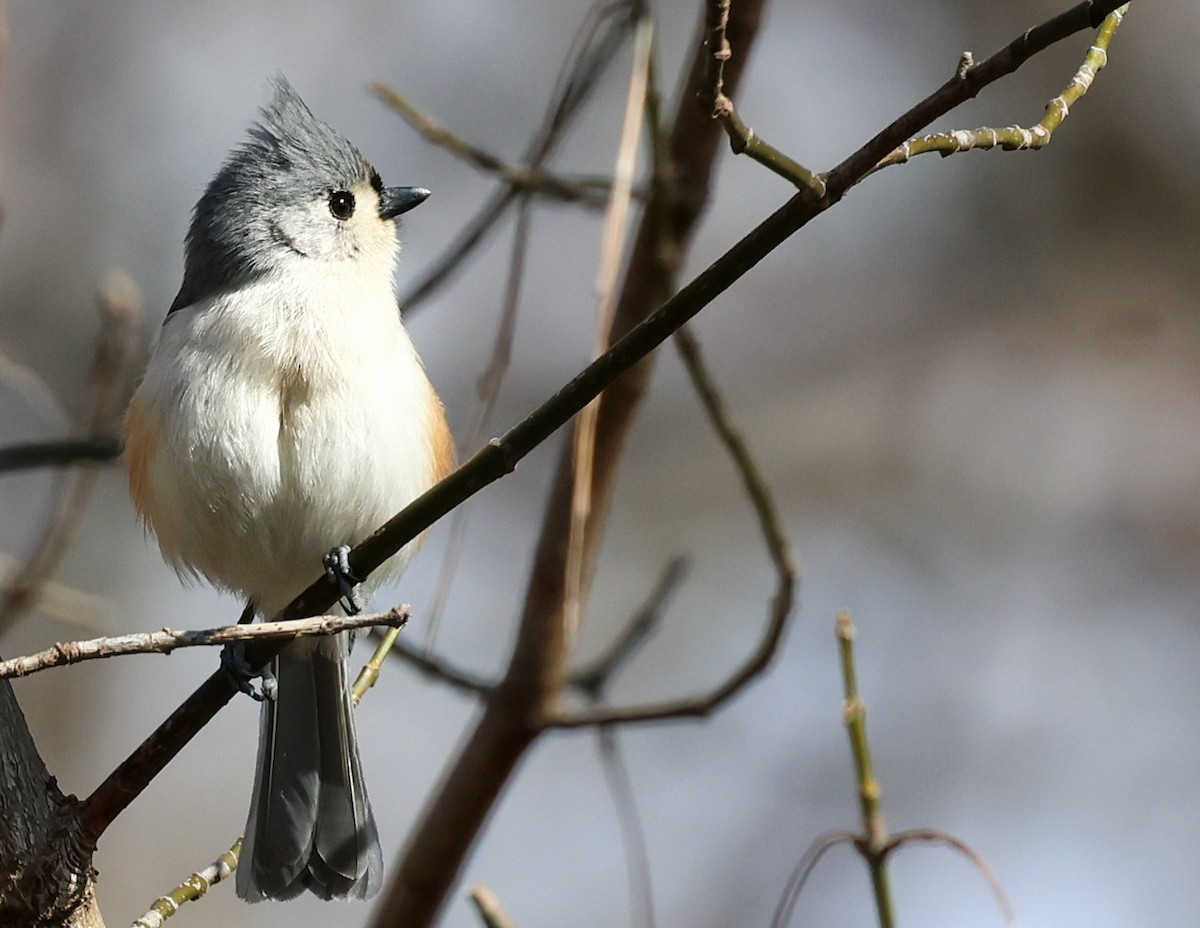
[134,265,443,615]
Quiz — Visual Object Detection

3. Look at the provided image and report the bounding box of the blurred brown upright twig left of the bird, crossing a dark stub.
[0,273,145,629]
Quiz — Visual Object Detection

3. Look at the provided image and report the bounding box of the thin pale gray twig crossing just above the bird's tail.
[0,606,409,679]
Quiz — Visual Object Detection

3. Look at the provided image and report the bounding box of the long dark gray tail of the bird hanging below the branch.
[238,634,383,902]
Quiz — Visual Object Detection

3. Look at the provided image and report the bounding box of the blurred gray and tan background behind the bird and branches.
[0,0,1200,928]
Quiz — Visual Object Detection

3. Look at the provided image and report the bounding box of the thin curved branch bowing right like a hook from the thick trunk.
[547,328,797,728]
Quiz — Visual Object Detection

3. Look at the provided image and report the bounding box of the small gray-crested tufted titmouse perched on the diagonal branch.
[125,77,454,902]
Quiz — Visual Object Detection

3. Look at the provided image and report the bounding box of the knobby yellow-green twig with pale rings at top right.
[875,4,1129,170]
